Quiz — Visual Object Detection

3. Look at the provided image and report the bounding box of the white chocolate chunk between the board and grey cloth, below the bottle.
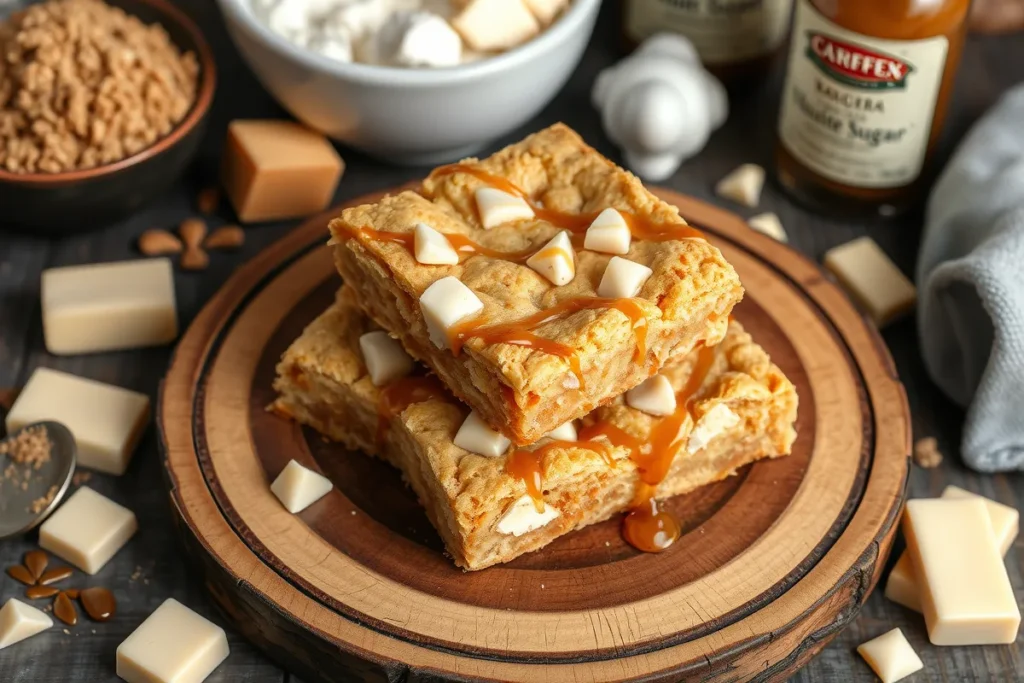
[824,237,918,328]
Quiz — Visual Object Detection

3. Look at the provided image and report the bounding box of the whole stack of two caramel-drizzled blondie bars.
[273,125,797,569]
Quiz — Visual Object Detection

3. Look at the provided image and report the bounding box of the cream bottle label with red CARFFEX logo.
[778,0,948,188]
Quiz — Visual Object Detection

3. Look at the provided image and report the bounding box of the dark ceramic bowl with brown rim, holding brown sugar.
[0,0,217,237]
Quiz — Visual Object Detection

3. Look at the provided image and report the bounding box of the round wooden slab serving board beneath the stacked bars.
[159,190,909,682]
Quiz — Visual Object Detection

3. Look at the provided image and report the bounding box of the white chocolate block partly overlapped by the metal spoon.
[6,368,150,474]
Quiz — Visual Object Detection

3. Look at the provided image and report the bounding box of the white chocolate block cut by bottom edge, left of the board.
[117,598,230,683]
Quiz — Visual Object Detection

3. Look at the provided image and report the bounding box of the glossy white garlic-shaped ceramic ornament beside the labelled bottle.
[592,34,729,180]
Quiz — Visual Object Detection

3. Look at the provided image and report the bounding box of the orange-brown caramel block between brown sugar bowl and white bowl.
[222,121,344,223]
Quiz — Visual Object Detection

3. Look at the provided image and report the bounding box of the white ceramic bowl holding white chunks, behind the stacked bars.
[218,0,601,164]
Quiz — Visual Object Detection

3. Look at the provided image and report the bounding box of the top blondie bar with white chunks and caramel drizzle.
[331,125,742,444]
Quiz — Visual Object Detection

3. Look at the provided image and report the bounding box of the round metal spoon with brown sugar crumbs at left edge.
[0,421,76,540]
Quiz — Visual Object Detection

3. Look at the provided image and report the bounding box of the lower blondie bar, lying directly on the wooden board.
[272,287,797,569]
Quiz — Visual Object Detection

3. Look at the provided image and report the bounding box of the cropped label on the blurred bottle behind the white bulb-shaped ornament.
[626,0,793,65]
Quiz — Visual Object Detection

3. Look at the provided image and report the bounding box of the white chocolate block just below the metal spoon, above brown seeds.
[39,486,138,573]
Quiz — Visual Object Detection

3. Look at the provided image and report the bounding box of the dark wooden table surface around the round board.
[0,0,1024,683]
